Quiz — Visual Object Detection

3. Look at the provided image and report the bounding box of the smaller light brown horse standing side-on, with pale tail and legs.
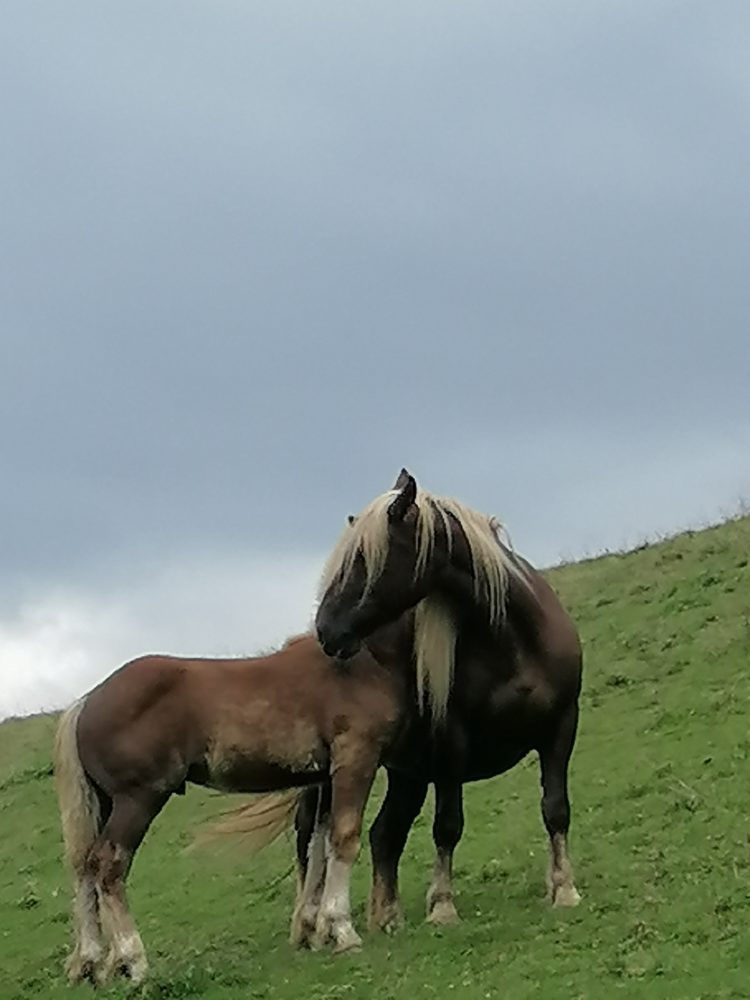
[55,635,411,982]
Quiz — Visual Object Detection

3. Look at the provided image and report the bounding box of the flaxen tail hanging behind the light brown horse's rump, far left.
[55,697,101,872]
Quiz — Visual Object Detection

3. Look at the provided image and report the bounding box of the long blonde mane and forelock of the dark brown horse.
[320,489,526,725]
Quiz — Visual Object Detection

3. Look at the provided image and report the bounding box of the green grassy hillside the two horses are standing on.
[0,518,750,1000]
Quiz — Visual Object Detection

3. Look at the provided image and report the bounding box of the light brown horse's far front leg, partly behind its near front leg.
[290,782,331,948]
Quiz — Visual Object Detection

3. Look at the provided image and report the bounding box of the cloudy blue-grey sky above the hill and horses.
[0,0,750,717]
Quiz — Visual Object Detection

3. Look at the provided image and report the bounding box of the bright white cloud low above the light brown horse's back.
[0,554,322,718]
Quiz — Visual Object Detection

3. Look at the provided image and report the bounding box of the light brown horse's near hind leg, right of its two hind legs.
[87,793,169,983]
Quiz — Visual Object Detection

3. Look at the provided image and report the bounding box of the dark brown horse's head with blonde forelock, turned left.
[315,469,449,658]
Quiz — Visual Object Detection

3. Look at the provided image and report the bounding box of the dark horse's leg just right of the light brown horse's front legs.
[369,771,427,934]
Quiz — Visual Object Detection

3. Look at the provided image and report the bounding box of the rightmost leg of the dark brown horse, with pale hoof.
[539,703,581,906]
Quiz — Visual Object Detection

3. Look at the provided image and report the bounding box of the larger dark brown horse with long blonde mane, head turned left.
[312,470,582,930]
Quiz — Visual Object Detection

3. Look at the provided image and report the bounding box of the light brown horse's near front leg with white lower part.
[313,734,379,953]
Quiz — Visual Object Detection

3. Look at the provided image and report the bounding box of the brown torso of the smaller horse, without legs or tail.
[78,636,406,794]
